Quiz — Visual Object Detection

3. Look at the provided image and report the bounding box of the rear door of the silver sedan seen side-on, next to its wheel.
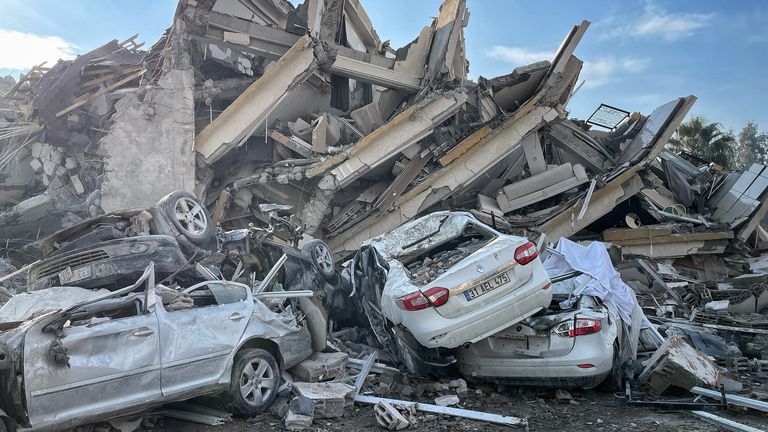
[157,281,254,398]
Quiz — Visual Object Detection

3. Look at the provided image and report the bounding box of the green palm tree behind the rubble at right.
[669,117,736,168]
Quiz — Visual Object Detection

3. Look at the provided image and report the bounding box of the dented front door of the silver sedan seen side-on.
[24,284,162,427]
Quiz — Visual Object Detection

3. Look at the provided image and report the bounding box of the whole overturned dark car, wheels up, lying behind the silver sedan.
[28,191,336,291]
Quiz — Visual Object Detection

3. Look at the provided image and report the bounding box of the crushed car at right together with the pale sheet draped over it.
[457,239,662,389]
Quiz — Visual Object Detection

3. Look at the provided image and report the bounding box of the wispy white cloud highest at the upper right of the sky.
[601,2,714,42]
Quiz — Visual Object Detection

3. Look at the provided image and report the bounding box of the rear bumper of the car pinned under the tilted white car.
[457,334,613,388]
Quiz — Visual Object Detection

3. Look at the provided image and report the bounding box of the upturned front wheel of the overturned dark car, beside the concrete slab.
[157,191,216,248]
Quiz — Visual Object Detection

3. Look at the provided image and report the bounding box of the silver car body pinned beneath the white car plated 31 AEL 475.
[456,273,658,389]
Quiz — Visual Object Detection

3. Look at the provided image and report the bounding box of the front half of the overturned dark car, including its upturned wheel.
[28,191,217,291]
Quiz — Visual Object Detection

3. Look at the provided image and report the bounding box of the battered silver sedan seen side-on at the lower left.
[0,265,312,432]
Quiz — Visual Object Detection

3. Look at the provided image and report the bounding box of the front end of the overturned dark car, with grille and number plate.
[29,235,186,291]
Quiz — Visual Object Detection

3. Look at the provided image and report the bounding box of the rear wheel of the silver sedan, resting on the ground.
[226,348,280,417]
